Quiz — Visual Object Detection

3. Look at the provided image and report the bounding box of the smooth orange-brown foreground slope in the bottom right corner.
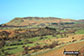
[33,41,84,56]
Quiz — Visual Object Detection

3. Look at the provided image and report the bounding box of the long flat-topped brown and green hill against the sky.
[6,17,75,26]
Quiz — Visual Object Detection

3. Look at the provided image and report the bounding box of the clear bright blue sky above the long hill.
[0,0,84,24]
